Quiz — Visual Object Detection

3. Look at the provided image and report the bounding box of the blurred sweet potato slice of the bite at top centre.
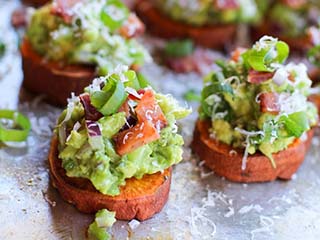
[135,0,236,48]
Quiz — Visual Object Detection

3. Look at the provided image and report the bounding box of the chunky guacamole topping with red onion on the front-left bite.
[56,67,190,196]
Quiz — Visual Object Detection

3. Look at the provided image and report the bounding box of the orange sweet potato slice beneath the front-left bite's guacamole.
[49,137,172,220]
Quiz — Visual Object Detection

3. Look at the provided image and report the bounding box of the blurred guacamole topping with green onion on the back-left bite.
[26,0,150,75]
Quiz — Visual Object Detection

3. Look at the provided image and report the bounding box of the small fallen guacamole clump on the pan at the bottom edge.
[88,209,116,240]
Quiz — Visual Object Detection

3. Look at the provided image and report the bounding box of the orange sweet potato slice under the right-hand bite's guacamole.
[192,120,313,182]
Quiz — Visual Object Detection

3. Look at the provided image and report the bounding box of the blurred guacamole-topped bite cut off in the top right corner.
[253,0,320,50]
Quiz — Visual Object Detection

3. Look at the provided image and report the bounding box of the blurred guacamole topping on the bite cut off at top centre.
[156,0,260,26]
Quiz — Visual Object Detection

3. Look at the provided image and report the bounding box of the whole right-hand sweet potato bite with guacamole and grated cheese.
[192,36,318,182]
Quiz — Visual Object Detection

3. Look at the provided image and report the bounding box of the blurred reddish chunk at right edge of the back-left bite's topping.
[119,14,145,38]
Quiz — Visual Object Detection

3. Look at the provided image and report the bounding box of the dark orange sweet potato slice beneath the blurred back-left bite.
[20,39,96,106]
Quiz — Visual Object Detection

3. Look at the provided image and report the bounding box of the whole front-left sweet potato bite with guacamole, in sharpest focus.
[49,68,190,220]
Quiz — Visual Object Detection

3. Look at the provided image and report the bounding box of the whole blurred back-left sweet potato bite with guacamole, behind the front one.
[21,0,150,105]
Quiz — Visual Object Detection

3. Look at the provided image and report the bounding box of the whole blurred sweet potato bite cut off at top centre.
[136,0,259,48]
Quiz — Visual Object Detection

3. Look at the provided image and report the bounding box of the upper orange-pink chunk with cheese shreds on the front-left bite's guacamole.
[135,90,167,131]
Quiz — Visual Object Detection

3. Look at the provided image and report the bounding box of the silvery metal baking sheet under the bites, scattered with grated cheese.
[0,0,320,240]
